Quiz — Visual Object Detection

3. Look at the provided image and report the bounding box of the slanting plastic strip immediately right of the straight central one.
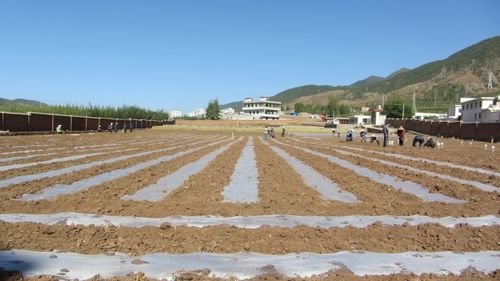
[271,142,358,203]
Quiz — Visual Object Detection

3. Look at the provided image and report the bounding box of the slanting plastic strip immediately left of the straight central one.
[122,137,239,199]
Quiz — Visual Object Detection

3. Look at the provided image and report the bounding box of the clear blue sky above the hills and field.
[0,0,500,112]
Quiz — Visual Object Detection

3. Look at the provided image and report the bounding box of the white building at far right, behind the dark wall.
[460,96,500,123]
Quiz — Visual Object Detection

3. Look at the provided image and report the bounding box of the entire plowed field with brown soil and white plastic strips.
[0,129,500,281]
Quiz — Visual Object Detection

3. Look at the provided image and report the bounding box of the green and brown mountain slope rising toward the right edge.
[271,36,500,110]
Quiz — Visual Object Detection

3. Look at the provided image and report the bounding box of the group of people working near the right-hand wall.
[346,125,436,148]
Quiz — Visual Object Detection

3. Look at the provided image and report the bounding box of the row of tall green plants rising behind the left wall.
[0,103,169,120]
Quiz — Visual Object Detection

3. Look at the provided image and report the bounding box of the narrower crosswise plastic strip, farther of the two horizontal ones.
[0,212,500,229]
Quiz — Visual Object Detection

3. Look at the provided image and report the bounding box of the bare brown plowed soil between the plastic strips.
[0,129,500,281]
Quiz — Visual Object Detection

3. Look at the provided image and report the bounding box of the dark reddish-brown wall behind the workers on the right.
[385,118,500,142]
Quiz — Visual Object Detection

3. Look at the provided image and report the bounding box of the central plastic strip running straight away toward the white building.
[222,137,259,203]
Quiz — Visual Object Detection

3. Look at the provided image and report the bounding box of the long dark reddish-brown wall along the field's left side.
[0,112,166,132]
